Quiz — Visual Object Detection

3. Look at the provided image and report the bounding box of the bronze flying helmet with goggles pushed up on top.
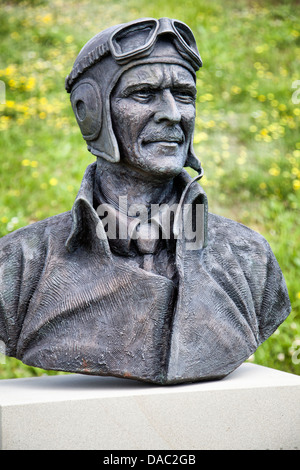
[65,18,202,172]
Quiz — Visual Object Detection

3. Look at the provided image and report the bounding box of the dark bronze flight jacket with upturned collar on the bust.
[0,163,290,384]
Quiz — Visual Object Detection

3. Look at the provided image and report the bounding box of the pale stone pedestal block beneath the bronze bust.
[0,363,300,450]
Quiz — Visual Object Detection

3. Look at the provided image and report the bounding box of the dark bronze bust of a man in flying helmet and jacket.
[0,18,290,384]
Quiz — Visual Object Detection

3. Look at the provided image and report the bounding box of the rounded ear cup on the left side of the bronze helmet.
[71,78,102,141]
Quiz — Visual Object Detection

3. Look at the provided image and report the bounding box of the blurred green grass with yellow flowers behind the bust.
[0,0,300,379]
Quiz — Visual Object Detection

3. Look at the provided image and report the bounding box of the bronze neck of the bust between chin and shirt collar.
[96,158,175,208]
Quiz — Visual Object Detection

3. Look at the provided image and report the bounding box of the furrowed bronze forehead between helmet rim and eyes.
[115,64,195,91]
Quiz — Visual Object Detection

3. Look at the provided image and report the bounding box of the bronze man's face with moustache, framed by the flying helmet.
[111,64,196,179]
